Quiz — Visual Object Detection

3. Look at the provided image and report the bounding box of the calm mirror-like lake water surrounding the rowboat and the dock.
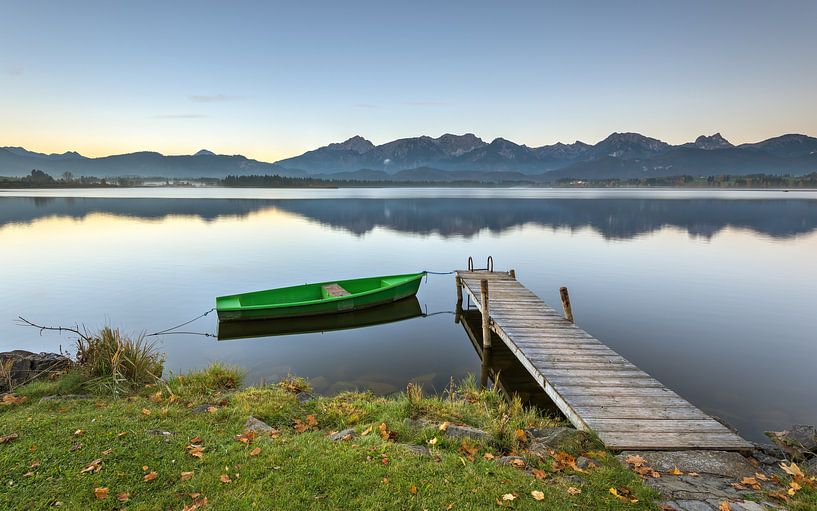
[0,188,817,440]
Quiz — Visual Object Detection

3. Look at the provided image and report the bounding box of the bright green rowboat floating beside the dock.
[216,273,425,321]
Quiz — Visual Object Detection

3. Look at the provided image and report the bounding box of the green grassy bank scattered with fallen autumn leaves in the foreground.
[0,366,654,510]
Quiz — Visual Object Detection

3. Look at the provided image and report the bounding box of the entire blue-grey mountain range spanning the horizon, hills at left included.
[0,133,817,182]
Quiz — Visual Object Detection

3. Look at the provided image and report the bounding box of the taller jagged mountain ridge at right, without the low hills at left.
[277,133,817,181]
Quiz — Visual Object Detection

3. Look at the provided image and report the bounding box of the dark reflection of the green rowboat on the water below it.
[218,296,423,341]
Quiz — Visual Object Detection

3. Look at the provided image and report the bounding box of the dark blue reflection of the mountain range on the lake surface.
[0,197,817,239]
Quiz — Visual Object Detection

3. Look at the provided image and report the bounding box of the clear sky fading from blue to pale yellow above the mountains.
[0,0,817,160]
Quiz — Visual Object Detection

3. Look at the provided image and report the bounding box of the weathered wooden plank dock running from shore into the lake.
[456,270,752,451]
